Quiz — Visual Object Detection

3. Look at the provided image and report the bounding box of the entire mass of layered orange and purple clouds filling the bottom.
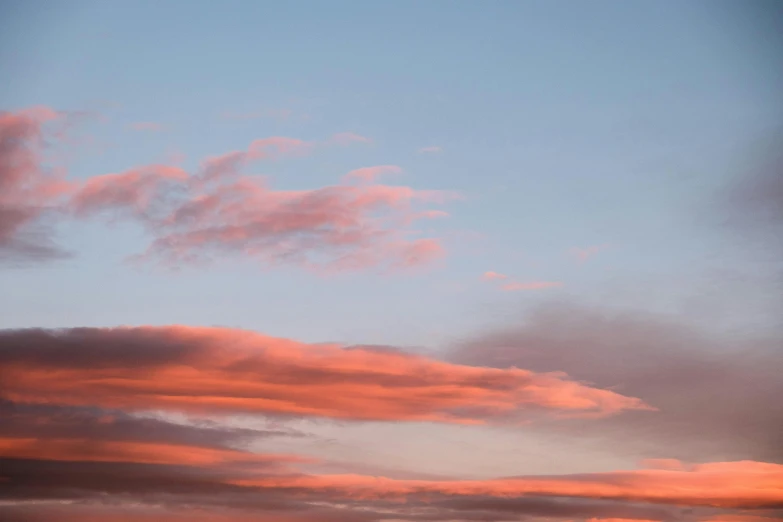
[0,326,783,522]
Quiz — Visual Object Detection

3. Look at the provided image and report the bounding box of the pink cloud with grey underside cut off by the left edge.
[0,107,71,259]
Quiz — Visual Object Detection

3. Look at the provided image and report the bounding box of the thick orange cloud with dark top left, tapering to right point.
[0,326,650,423]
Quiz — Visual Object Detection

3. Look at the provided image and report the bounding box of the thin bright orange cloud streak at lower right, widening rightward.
[234,461,783,508]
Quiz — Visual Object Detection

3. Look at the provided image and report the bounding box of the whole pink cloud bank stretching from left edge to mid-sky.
[0,116,456,272]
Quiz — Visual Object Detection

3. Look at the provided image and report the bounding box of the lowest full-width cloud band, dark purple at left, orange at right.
[0,452,783,521]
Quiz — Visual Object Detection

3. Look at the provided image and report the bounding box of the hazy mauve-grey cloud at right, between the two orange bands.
[453,298,783,462]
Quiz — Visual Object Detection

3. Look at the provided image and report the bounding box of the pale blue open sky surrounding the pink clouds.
[0,1,783,347]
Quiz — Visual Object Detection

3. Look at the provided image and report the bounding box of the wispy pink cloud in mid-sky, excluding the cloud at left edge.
[62,137,456,272]
